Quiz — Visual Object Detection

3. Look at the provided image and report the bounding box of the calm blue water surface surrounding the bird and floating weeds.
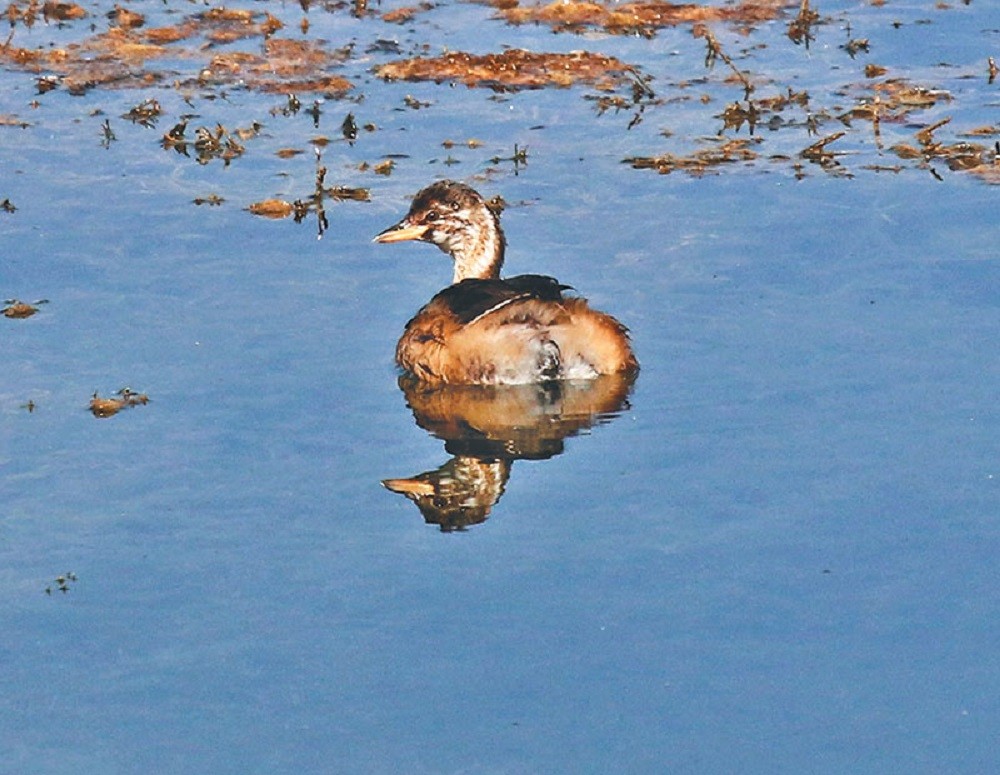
[0,2,1000,773]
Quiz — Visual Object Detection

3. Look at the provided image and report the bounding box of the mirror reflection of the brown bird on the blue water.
[382,373,635,531]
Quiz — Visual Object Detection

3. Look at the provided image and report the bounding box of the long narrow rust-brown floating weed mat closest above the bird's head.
[375,48,635,90]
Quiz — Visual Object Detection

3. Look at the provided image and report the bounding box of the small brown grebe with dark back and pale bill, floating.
[375,180,638,385]
